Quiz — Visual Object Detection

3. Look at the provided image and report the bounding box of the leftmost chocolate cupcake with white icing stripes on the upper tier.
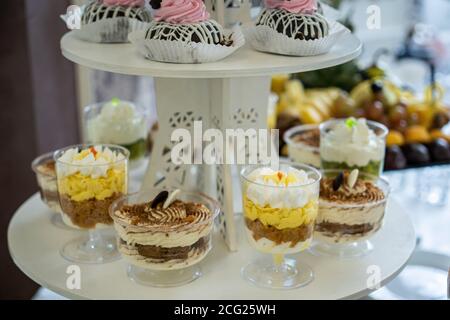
[76,0,152,43]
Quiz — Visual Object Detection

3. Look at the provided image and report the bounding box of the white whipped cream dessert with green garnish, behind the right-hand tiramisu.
[320,118,388,177]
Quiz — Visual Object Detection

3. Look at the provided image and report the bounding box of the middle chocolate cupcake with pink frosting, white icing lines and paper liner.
[130,0,244,63]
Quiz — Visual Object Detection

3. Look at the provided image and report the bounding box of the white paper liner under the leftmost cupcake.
[74,17,149,43]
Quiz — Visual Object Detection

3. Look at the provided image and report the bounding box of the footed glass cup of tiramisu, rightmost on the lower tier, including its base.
[310,170,390,259]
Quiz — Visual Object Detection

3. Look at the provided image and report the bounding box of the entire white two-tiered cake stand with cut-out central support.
[8,33,415,299]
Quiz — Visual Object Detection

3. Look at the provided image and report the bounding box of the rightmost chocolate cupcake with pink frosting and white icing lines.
[248,0,348,56]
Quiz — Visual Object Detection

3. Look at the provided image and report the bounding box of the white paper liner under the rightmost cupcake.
[244,21,350,57]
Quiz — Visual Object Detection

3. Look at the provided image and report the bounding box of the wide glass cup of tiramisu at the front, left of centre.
[110,188,220,287]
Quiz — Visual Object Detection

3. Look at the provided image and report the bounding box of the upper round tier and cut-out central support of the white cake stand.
[61,33,362,251]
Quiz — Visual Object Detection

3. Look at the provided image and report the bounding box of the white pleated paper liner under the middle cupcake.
[129,28,245,63]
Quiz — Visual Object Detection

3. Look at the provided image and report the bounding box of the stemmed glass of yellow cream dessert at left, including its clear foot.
[54,145,129,264]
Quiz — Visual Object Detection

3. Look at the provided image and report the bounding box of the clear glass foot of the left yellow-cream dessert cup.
[61,229,120,264]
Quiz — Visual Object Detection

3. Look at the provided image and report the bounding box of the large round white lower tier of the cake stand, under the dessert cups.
[8,194,415,300]
